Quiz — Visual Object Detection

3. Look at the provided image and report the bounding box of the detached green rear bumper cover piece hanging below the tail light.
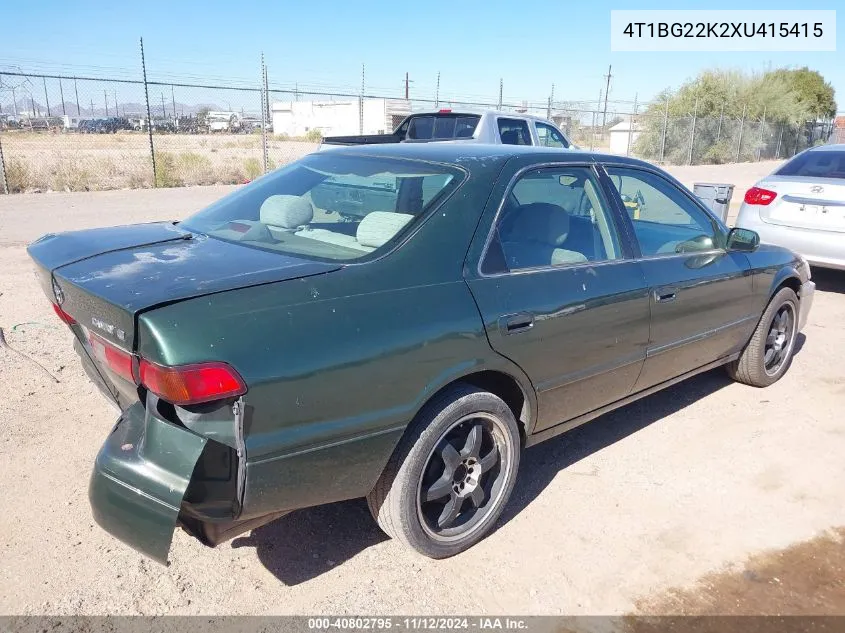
[88,403,207,564]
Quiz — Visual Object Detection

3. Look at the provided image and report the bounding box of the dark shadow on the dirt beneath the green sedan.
[232,362,768,585]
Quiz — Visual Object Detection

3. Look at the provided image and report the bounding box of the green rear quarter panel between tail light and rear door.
[139,162,533,518]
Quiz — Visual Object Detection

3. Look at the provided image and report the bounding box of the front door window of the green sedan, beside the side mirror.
[607,167,723,256]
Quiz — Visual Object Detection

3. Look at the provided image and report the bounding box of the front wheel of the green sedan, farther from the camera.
[726,288,799,387]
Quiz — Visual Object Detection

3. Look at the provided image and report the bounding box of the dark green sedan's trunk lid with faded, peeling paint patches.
[27,223,340,351]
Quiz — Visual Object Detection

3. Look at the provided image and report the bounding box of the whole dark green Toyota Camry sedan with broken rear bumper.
[29,143,814,562]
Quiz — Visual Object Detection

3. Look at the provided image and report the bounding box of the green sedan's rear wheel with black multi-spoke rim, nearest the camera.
[367,385,521,558]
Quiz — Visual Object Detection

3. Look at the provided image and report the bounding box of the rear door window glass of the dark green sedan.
[485,167,622,272]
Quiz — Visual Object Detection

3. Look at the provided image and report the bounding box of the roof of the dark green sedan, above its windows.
[320,141,651,166]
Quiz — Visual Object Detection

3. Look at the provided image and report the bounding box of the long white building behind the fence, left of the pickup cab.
[271,97,411,136]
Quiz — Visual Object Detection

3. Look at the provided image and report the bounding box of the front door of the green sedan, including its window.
[606,165,759,391]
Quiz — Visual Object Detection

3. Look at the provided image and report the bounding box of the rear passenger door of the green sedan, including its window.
[466,159,649,431]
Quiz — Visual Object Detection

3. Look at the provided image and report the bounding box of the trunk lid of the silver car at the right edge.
[757,176,845,232]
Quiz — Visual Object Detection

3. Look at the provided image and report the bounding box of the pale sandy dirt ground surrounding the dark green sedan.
[0,163,845,615]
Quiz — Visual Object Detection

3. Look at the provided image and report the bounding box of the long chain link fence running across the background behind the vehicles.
[0,69,842,193]
